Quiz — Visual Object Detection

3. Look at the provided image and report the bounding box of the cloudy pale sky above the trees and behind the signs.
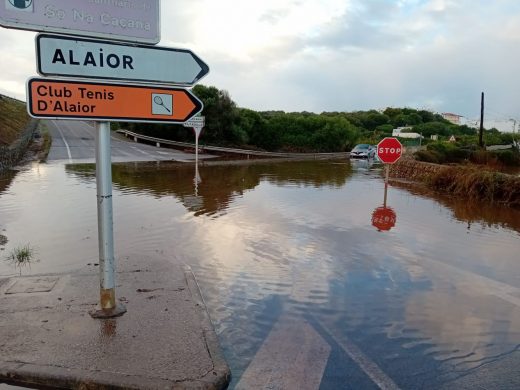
[0,0,520,131]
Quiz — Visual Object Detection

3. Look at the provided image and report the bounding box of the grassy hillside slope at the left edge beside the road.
[0,95,30,146]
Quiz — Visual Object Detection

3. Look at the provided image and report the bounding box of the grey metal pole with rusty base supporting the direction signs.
[90,122,126,318]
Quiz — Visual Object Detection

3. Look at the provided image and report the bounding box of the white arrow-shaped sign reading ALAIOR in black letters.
[36,34,209,86]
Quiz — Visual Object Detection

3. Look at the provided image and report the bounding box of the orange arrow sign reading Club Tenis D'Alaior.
[27,78,203,123]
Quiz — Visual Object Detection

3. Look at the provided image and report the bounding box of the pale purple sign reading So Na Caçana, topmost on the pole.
[0,0,161,44]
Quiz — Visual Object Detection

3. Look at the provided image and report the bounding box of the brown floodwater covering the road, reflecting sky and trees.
[0,161,520,389]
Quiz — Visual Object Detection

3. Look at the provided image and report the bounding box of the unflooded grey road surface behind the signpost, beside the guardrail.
[44,120,202,163]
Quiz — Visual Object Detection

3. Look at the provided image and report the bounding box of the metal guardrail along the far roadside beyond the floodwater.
[117,130,350,160]
